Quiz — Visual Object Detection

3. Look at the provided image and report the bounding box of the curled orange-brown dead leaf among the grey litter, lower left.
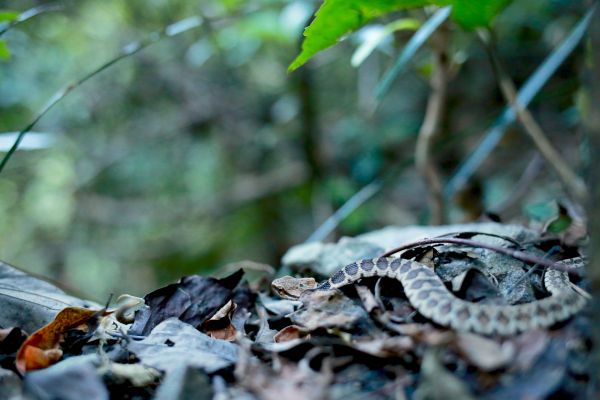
[16,307,103,374]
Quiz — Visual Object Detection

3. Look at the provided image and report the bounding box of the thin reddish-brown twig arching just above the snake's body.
[381,238,574,273]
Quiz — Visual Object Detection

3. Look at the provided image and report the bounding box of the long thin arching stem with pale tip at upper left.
[0,17,202,173]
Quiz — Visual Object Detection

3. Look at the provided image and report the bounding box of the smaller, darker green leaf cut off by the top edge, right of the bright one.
[450,0,511,30]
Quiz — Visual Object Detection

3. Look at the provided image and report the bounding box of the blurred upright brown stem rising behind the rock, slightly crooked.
[415,29,448,225]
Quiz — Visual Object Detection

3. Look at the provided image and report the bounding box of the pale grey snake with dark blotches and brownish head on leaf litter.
[271,257,589,336]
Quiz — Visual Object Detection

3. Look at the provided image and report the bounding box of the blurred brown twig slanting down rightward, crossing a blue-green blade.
[479,31,587,202]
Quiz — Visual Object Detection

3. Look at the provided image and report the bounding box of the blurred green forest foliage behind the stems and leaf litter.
[0,0,589,301]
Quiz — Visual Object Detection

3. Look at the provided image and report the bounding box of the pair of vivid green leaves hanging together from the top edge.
[289,0,510,71]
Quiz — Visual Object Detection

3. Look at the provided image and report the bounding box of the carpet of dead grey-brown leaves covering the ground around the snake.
[0,226,591,400]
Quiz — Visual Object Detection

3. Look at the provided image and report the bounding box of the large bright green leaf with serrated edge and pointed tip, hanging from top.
[288,0,431,71]
